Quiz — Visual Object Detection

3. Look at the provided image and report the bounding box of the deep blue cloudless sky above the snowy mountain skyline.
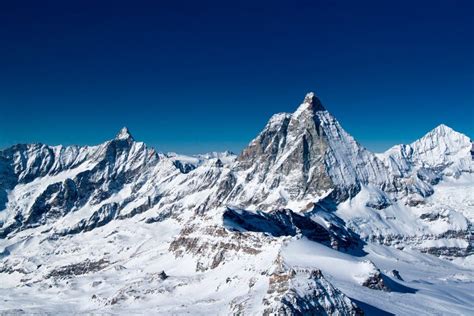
[0,0,474,153]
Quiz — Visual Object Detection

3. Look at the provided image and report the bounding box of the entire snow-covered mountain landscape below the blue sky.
[0,93,474,315]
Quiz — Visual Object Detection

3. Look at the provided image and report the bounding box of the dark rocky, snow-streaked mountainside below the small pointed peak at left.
[0,128,170,237]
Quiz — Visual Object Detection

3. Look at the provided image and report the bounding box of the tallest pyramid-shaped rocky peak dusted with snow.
[216,93,391,210]
